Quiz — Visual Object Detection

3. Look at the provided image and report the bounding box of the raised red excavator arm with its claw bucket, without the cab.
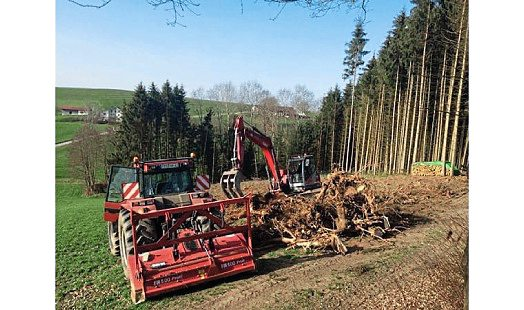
[220,116,283,198]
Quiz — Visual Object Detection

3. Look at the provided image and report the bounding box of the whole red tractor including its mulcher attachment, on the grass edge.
[104,157,255,303]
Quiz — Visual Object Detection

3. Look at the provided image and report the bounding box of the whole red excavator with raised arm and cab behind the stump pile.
[220,116,320,198]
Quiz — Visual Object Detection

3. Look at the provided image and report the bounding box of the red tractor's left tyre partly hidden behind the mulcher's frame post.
[118,209,158,278]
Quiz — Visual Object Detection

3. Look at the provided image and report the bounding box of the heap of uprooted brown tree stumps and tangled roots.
[248,172,390,254]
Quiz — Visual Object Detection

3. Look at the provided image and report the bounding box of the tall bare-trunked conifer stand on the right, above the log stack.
[316,0,469,173]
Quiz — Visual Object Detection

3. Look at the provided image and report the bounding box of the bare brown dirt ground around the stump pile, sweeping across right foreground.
[158,176,468,309]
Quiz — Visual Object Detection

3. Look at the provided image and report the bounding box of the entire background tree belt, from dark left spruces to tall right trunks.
[72,0,469,190]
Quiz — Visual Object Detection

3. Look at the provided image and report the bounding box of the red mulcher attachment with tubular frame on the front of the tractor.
[123,196,255,303]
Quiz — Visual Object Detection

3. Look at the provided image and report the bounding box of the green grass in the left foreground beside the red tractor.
[55,146,137,309]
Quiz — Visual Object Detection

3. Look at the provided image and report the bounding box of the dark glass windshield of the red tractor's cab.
[142,169,193,197]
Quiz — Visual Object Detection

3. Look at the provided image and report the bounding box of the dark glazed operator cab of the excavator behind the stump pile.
[287,155,320,192]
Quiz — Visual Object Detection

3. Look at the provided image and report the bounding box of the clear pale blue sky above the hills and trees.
[56,0,411,98]
